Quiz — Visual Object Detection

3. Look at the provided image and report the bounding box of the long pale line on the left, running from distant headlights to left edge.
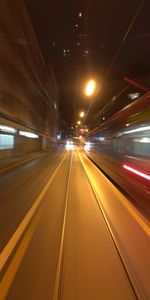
[0,153,68,272]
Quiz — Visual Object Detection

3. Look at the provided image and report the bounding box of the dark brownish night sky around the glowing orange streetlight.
[26,0,150,124]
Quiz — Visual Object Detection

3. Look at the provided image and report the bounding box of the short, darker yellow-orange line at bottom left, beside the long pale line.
[0,210,42,300]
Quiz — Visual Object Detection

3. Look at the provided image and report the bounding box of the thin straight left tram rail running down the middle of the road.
[52,153,73,300]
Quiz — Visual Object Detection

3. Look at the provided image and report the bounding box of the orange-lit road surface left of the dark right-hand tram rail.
[0,150,146,300]
